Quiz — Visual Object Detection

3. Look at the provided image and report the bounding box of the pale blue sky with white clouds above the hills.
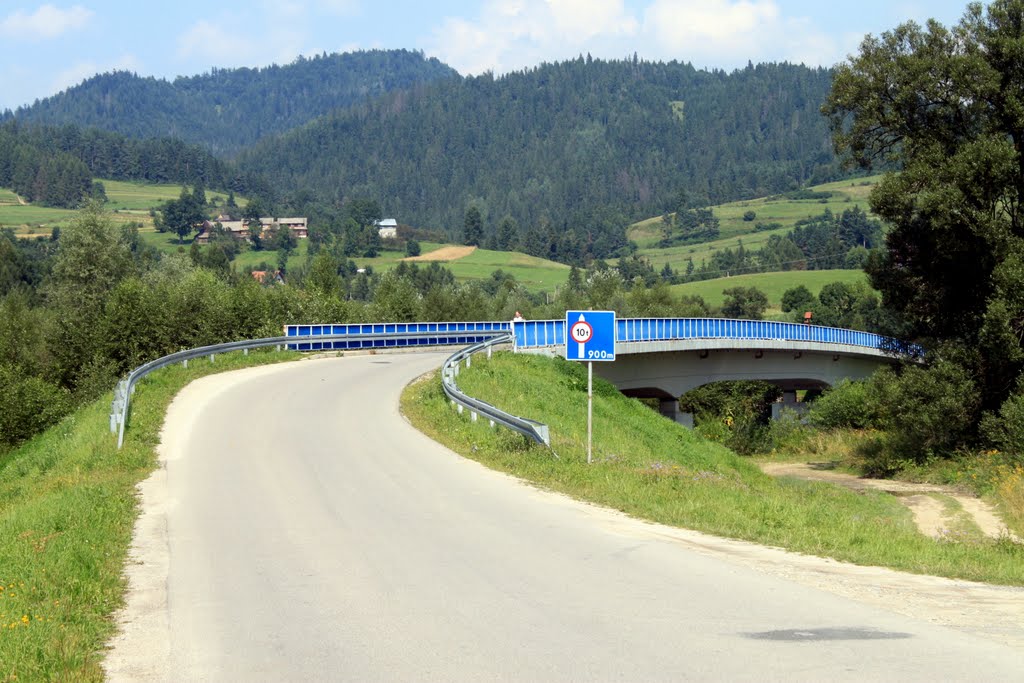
[0,0,967,110]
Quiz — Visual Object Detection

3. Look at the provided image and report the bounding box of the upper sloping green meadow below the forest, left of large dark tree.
[627,176,881,271]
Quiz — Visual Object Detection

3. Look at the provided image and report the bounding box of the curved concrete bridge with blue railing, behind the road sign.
[513,318,898,425]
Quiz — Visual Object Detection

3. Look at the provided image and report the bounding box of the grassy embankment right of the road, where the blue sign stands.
[402,353,1024,585]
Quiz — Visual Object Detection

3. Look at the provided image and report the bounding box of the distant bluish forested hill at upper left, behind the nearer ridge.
[8,50,459,156]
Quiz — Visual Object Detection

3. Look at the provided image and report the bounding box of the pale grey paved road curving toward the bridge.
[105,353,1024,681]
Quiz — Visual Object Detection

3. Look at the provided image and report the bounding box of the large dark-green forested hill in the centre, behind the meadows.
[240,57,838,240]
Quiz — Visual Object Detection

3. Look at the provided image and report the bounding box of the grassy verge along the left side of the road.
[0,351,298,682]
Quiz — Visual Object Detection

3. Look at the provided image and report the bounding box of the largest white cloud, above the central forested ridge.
[425,0,855,74]
